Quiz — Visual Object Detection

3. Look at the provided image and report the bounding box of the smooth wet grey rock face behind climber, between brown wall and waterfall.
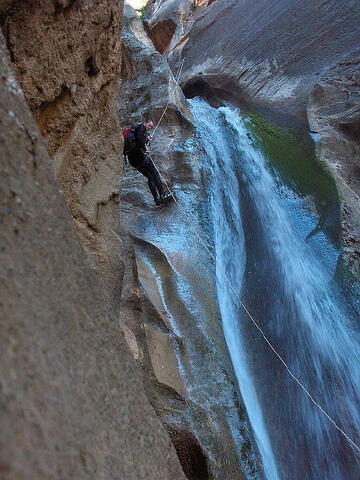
[119,7,257,480]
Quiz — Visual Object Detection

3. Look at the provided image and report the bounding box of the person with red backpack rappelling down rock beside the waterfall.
[123,120,172,206]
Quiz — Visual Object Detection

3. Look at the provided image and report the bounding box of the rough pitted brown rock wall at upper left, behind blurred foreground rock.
[0,0,123,301]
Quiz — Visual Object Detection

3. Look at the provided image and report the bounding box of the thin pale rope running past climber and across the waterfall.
[149,58,360,453]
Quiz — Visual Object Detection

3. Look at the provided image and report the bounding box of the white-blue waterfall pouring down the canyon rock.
[191,99,360,480]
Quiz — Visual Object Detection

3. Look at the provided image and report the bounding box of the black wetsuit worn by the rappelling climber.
[127,123,164,201]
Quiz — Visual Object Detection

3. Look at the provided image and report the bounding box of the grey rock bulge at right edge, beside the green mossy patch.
[307,49,360,275]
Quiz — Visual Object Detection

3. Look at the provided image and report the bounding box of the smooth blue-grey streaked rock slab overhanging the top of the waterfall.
[181,0,360,118]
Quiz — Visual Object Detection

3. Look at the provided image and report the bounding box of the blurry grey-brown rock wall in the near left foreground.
[0,33,184,480]
